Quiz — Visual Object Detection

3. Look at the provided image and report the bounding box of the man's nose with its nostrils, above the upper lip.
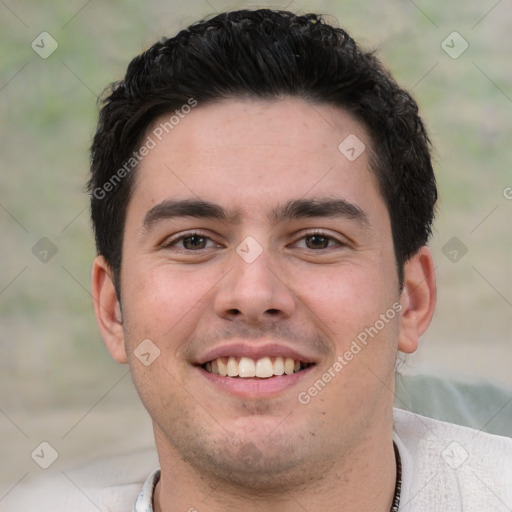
[214,249,296,326]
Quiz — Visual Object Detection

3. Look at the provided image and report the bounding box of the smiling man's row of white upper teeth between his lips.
[204,356,301,378]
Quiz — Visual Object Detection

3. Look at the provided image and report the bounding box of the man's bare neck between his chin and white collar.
[154,418,396,512]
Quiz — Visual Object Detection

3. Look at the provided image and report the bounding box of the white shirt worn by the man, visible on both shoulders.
[6,409,512,512]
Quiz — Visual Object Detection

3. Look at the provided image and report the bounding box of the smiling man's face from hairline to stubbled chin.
[96,99,424,488]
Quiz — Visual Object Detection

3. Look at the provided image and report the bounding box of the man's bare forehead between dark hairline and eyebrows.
[132,98,378,219]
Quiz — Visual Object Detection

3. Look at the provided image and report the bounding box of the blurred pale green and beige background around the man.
[0,0,512,488]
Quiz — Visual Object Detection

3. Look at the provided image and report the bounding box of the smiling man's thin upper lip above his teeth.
[196,342,316,365]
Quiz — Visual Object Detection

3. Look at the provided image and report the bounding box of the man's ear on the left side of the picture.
[91,256,127,363]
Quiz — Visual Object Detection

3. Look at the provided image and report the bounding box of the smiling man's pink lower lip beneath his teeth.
[197,365,313,398]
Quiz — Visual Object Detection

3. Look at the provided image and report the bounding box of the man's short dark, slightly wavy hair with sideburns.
[88,9,437,296]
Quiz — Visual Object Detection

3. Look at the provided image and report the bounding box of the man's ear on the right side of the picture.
[398,247,437,354]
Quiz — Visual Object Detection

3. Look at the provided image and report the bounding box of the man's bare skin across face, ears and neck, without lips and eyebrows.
[92,98,436,512]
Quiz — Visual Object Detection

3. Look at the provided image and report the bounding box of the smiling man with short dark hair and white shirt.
[89,10,512,512]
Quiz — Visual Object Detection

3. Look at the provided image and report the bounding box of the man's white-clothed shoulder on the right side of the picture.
[393,409,512,512]
